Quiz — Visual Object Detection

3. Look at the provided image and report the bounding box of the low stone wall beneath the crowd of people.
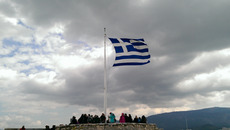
[56,123,163,130]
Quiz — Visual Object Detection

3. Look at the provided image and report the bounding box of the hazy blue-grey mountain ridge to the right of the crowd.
[147,107,230,130]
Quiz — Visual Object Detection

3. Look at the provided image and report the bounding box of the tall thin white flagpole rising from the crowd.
[104,28,107,123]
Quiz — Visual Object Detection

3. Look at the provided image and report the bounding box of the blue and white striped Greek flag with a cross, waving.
[109,38,150,66]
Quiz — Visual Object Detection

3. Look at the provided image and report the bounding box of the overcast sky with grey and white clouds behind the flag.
[0,0,230,129]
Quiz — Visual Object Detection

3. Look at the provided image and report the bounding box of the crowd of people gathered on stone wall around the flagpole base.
[70,112,147,124]
